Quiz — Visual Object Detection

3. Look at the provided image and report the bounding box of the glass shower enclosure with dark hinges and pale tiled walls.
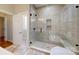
[29,4,79,52]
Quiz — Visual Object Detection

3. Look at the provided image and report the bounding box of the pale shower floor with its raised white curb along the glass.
[30,41,56,54]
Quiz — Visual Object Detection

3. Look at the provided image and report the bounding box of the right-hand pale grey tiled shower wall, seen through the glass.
[61,4,79,48]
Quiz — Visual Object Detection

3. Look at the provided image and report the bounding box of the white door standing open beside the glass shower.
[13,12,28,55]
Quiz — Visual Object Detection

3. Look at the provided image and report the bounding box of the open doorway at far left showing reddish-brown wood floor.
[0,17,13,48]
